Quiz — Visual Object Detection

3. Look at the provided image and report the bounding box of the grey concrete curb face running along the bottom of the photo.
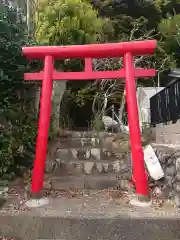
[0,215,180,240]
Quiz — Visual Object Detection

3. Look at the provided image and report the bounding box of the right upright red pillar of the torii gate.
[124,53,148,196]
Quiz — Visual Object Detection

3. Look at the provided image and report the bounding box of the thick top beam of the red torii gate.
[22,40,157,59]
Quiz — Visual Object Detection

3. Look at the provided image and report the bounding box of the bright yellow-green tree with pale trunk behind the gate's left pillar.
[35,0,105,128]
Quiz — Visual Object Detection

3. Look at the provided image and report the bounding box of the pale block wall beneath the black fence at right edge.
[153,120,180,145]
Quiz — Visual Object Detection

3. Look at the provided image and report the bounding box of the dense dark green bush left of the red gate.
[0,6,37,179]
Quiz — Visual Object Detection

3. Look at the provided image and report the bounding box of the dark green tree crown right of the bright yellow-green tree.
[91,0,161,35]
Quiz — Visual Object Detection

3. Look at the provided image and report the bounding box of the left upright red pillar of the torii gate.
[32,56,54,193]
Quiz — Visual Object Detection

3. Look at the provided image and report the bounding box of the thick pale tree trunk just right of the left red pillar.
[52,80,67,130]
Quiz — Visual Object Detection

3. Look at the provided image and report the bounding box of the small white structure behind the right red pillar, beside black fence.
[136,87,164,129]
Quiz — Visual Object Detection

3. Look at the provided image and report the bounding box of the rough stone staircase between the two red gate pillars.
[46,132,131,189]
